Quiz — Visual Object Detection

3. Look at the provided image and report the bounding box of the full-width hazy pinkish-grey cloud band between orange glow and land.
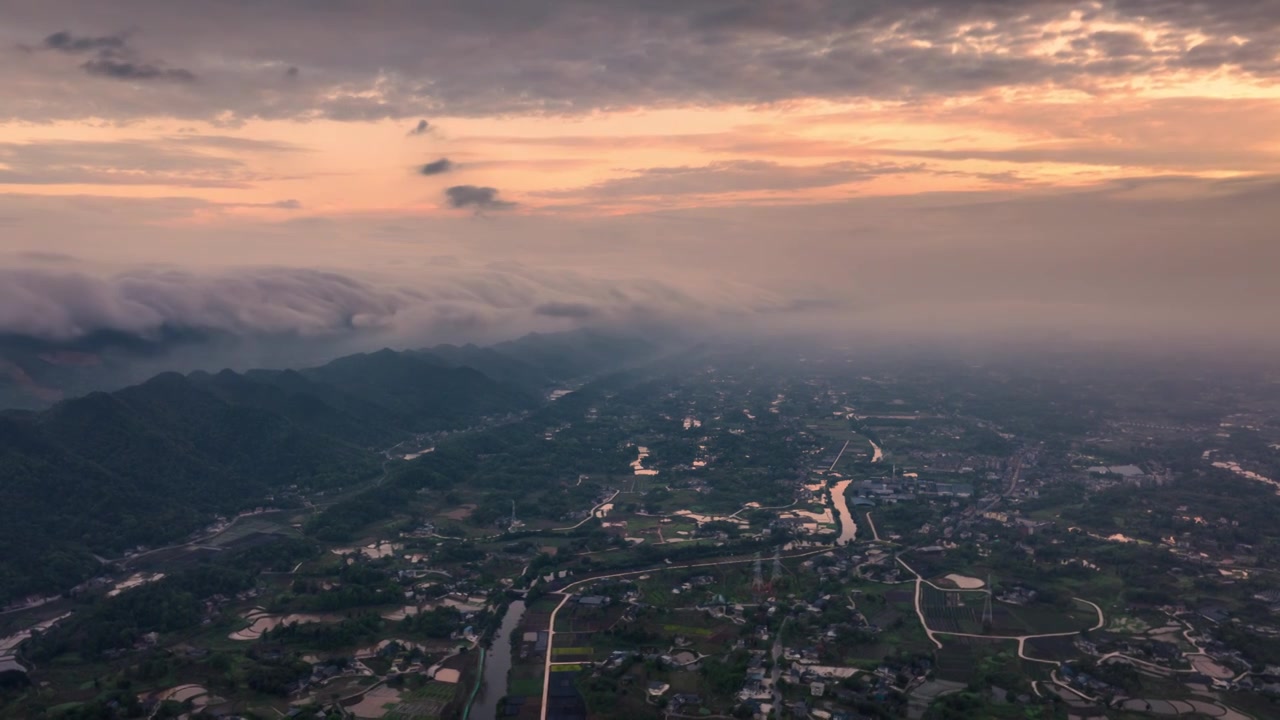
[0,176,1280,363]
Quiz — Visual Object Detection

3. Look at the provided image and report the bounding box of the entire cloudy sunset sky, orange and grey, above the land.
[0,0,1280,386]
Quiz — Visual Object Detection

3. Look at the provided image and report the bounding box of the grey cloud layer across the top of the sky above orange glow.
[0,0,1280,121]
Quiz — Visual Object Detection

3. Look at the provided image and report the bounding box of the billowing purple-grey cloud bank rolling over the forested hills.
[0,264,767,363]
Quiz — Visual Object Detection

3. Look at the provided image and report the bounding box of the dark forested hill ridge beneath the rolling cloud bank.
[0,333,660,606]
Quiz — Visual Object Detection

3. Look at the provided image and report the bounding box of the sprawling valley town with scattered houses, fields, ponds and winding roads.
[0,345,1280,720]
